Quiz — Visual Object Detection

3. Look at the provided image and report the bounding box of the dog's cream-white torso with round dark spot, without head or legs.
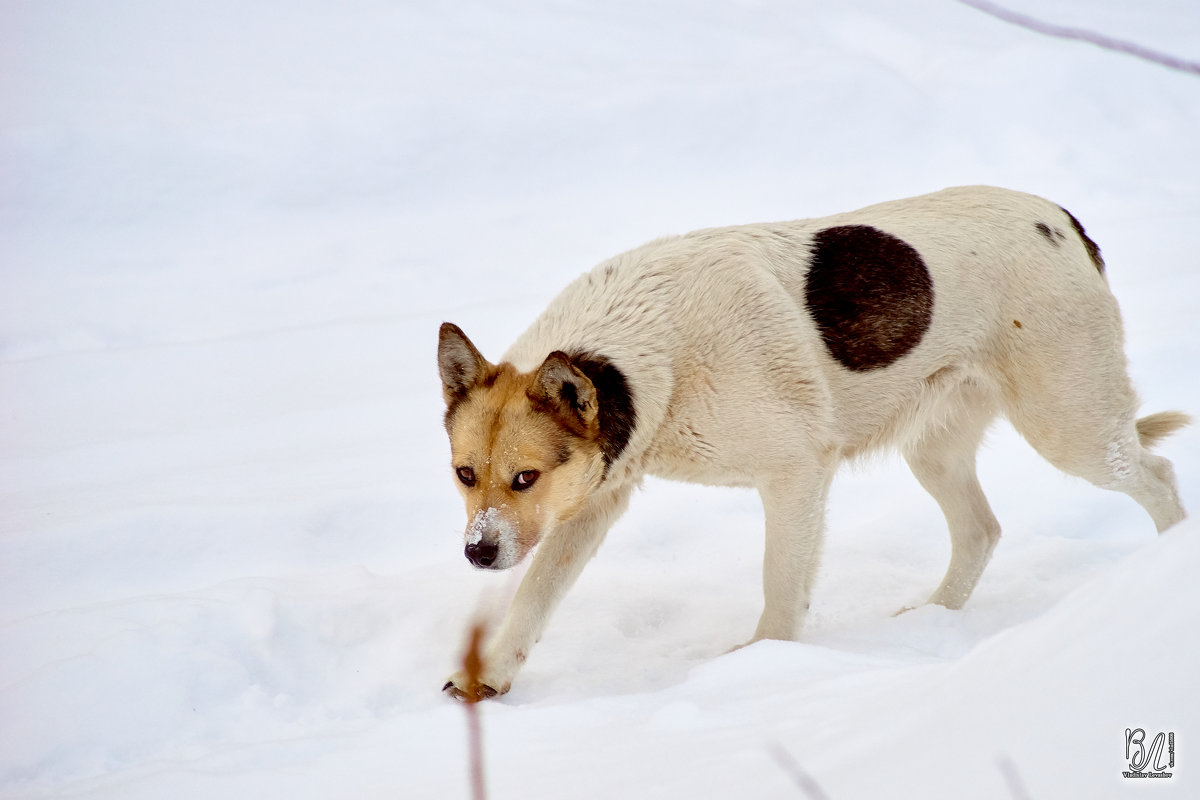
[506,187,1152,483]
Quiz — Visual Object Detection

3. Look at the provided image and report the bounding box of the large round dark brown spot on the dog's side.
[804,225,934,371]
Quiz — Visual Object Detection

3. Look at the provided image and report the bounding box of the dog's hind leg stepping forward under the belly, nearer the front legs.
[904,384,1000,608]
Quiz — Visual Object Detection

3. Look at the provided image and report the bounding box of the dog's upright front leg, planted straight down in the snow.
[751,467,834,642]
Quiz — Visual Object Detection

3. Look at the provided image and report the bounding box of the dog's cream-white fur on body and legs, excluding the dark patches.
[446,187,1183,692]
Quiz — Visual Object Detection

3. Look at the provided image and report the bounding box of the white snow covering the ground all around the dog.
[0,0,1200,800]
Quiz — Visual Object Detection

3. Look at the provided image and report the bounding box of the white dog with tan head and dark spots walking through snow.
[438,187,1189,699]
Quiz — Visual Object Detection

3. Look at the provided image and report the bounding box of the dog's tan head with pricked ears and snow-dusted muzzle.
[438,323,607,570]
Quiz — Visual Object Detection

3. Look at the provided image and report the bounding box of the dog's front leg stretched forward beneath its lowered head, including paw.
[443,487,630,699]
